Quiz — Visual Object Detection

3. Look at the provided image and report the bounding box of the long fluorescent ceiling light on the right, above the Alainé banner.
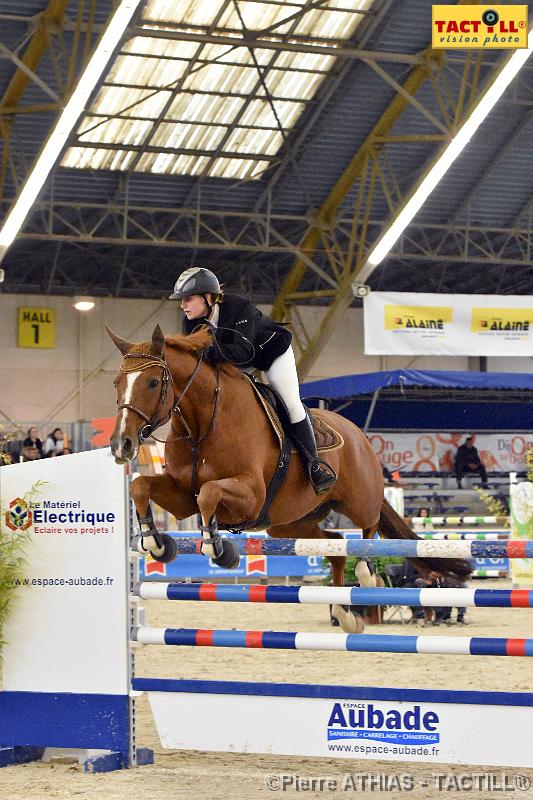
[356,29,533,282]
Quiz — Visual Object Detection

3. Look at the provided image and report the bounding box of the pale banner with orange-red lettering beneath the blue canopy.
[368,431,533,473]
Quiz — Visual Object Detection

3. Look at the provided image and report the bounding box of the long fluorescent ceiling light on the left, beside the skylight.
[0,0,142,263]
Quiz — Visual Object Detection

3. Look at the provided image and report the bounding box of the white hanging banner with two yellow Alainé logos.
[364,292,533,356]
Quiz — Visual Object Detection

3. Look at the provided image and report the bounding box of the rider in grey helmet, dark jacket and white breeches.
[169,267,337,494]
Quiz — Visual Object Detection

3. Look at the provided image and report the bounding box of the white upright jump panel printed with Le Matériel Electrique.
[0,448,129,695]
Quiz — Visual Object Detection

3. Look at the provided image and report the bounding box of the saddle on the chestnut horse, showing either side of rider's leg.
[243,372,344,453]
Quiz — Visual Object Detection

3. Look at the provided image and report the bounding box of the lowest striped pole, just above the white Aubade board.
[132,627,533,656]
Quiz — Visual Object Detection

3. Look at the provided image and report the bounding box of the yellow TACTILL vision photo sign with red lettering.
[431,4,528,50]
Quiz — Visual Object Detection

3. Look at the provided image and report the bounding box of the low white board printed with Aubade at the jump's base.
[148,681,531,768]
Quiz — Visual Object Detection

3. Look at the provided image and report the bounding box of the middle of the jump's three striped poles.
[133,581,533,608]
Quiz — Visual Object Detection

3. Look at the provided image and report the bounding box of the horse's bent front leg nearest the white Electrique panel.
[131,475,196,564]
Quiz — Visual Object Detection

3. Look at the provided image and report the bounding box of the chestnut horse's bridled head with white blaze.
[106,325,174,464]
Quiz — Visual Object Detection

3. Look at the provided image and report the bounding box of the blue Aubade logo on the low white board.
[328,703,440,744]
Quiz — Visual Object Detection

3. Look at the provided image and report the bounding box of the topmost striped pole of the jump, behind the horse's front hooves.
[149,536,533,558]
